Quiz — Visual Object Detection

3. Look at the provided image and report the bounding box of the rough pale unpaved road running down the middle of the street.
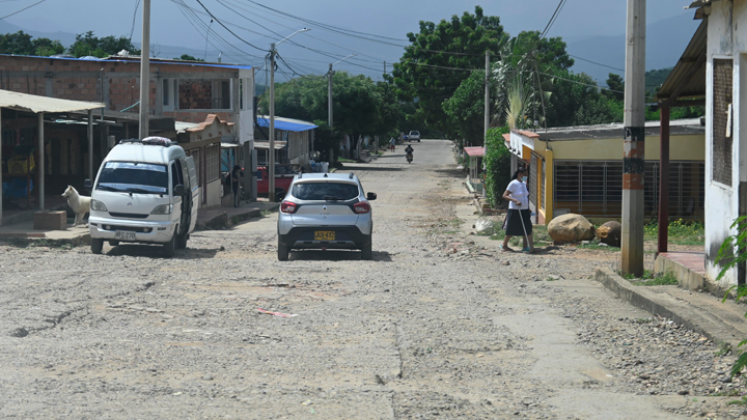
[0,141,747,419]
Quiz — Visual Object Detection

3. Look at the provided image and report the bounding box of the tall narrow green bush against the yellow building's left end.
[485,127,511,208]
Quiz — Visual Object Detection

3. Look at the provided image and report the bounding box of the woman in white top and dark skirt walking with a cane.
[501,168,534,253]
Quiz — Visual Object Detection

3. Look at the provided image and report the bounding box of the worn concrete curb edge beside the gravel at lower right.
[594,268,742,349]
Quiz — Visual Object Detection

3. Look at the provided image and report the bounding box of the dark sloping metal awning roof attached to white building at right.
[656,19,708,104]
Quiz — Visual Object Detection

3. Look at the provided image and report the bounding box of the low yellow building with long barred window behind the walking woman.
[504,119,705,224]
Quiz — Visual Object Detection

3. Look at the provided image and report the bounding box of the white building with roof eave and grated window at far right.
[681,0,747,287]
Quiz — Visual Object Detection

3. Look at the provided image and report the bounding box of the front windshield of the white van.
[96,162,169,194]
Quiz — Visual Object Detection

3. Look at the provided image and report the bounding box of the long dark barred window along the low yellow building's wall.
[553,161,705,217]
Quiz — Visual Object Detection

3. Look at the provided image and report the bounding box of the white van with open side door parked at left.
[86,137,200,257]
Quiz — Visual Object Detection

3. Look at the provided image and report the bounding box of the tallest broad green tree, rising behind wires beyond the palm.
[391,6,507,135]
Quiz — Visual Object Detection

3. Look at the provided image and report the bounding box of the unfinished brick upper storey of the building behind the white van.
[0,55,254,137]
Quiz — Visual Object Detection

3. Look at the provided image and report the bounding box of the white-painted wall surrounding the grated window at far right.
[705,0,747,286]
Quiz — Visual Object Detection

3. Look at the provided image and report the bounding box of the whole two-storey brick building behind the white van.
[0,55,254,208]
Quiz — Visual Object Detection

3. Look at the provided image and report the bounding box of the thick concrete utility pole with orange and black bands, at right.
[620,0,646,276]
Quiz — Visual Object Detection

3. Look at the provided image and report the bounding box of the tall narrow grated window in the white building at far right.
[712,58,734,186]
